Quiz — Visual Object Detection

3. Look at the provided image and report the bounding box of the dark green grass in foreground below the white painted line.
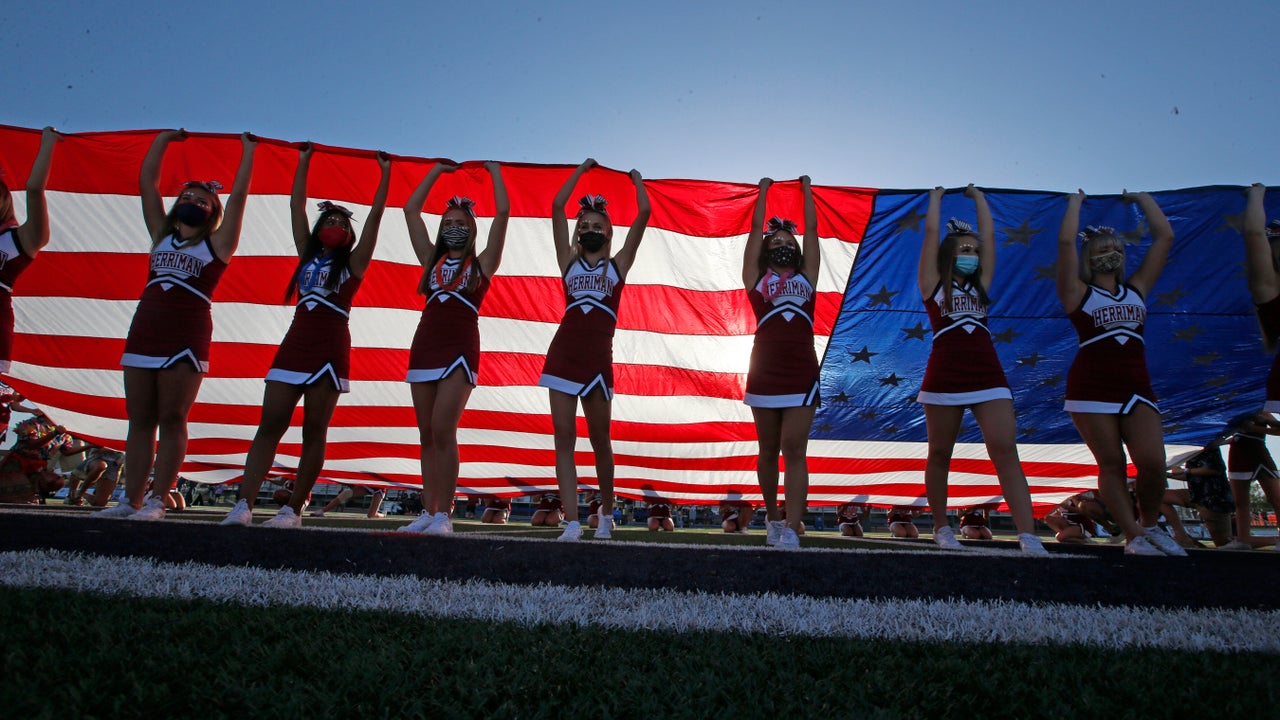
[0,589,1280,720]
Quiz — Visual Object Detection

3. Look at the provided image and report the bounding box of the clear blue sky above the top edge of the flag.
[10,0,1280,193]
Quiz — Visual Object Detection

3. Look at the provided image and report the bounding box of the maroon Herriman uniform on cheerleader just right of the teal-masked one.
[1064,283,1160,415]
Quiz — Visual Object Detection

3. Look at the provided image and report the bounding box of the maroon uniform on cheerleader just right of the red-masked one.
[404,256,489,386]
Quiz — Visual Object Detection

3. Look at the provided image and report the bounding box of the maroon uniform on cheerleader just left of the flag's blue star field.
[742,269,820,409]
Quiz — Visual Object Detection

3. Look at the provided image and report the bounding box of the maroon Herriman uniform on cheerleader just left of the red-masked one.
[120,233,227,373]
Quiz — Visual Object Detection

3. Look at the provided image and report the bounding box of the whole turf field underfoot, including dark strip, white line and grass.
[0,506,1280,717]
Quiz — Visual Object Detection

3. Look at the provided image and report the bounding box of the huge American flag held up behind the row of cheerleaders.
[0,126,1268,512]
